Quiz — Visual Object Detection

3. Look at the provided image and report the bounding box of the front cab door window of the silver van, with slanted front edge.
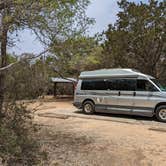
[137,80,158,92]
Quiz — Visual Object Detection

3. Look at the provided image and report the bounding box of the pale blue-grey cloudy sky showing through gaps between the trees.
[9,0,148,55]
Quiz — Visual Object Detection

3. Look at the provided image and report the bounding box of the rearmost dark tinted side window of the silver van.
[81,80,108,90]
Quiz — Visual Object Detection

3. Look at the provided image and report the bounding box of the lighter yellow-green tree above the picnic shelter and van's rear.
[51,35,102,77]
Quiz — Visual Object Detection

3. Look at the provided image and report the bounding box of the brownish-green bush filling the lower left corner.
[0,103,45,166]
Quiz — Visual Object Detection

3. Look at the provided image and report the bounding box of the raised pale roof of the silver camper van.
[79,68,153,79]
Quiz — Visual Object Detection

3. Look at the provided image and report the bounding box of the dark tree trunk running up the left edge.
[0,24,8,113]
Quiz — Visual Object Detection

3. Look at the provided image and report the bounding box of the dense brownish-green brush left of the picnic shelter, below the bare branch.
[5,57,49,100]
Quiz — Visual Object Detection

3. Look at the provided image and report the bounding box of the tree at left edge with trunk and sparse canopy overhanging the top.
[0,0,92,111]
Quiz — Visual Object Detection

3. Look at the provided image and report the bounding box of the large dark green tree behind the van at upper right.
[103,0,166,77]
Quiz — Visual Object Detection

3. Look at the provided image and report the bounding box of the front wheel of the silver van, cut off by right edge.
[156,105,166,122]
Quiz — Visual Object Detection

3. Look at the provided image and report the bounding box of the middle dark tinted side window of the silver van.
[108,79,136,91]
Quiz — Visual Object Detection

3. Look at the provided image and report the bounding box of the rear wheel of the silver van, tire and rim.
[83,101,95,114]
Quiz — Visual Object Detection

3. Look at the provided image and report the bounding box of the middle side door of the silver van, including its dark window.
[108,78,136,114]
